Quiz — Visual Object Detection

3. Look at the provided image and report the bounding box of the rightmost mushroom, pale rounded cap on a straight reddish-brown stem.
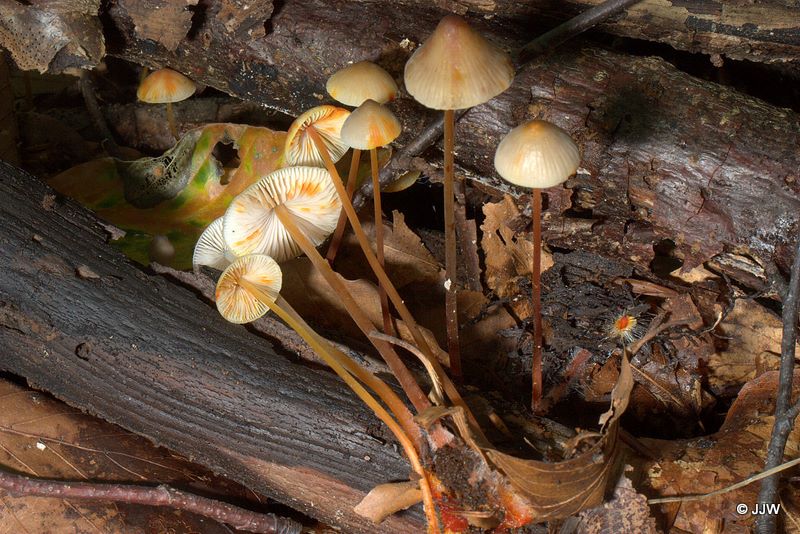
[494,120,581,412]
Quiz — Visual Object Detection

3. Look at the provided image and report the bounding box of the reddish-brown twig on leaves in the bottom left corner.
[0,469,302,534]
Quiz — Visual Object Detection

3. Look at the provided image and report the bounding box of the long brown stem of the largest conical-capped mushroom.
[444,109,462,382]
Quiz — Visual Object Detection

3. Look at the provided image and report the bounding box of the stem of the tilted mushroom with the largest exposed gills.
[275,204,431,412]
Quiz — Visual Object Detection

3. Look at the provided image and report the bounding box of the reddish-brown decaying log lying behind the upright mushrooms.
[108,0,800,285]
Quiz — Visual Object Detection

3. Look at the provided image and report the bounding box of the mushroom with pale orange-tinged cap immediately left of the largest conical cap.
[325,61,397,265]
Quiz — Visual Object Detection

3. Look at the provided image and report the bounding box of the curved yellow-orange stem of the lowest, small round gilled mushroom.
[247,294,440,532]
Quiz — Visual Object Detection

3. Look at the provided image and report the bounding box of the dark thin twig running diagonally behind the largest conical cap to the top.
[353,0,641,209]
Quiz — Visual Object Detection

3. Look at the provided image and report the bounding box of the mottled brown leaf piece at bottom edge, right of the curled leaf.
[577,476,657,534]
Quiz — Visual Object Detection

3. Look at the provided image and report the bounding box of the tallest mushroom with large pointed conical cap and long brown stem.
[405,15,514,384]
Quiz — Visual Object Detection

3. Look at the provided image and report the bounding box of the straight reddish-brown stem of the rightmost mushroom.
[531,188,543,413]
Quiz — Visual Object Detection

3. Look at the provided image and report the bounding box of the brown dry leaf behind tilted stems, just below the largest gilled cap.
[281,257,449,364]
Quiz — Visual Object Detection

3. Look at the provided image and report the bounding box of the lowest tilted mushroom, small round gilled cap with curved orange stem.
[216,254,439,532]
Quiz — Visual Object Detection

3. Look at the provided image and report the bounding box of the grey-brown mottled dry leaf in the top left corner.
[0,0,105,74]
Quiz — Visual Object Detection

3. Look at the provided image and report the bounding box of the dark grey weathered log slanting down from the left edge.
[0,162,422,533]
